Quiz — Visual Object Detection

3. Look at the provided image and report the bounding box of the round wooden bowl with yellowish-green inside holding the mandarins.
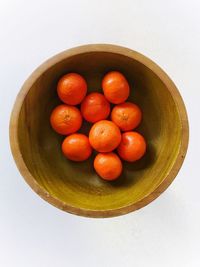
[10,44,188,217]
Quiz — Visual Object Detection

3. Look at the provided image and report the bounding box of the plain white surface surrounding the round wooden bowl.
[0,0,200,267]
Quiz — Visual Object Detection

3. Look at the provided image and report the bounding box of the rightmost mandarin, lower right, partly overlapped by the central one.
[117,132,146,162]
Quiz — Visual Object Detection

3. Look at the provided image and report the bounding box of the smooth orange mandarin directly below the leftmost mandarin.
[62,133,92,161]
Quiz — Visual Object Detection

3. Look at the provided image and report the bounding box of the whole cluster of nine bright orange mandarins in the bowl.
[50,71,146,180]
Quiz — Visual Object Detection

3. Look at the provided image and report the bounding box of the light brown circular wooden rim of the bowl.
[9,44,189,218]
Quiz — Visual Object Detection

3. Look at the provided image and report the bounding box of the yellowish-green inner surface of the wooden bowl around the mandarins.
[18,52,181,213]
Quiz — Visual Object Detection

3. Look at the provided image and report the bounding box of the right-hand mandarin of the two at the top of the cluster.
[102,71,130,104]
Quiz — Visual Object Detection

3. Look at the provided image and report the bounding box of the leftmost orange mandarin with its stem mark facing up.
[50,104,82,135]
